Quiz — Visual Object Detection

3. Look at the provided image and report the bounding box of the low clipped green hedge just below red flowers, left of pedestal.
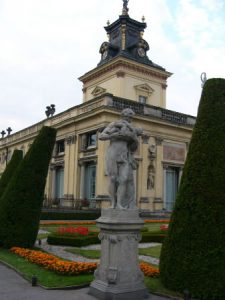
[47,233,101,247]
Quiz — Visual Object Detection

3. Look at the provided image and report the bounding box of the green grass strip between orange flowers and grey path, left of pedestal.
[0,249,93,288]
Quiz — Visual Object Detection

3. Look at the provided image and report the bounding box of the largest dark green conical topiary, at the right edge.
[160,79,225,300]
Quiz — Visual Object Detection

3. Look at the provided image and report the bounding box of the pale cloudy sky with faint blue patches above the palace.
[0,0,225,132]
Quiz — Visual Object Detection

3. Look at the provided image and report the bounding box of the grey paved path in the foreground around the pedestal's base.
[0,263,174,300]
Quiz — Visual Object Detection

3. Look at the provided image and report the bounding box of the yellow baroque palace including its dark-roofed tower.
[0,2,195,212]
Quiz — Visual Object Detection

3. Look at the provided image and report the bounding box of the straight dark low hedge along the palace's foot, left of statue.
[41,211,101,220]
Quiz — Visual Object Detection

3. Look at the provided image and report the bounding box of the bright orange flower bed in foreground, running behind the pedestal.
[10,247,159,277]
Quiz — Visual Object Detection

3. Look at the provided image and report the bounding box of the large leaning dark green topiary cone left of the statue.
[0,127,56,248]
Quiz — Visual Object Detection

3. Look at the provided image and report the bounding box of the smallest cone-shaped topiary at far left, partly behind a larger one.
[0,150,23,197]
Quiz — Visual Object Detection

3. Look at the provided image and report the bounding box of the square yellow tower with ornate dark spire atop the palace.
[79,1,171,108]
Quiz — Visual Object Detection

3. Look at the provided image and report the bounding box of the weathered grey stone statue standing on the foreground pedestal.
[99,108,142,209]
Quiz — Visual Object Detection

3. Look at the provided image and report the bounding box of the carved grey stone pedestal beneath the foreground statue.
[89,208,148,300]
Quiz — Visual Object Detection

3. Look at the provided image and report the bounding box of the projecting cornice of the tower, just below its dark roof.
[79,57,172,84]
